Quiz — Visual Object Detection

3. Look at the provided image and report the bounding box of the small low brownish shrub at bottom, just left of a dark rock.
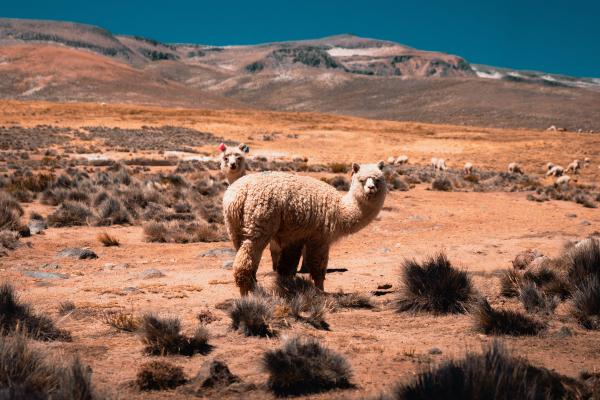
[135,360,187,390]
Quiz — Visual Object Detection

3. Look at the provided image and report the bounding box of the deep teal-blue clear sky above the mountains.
[0,0,600,77]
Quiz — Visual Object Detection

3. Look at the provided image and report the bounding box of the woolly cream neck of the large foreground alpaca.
[335,191,385,237]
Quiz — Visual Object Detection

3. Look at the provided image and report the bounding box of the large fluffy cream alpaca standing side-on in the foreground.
[223,161,386,295]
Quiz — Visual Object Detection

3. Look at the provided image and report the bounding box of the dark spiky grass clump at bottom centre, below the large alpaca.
[263,337,353,396]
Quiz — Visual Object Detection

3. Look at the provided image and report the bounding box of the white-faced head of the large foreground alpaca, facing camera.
[349,161,387,202]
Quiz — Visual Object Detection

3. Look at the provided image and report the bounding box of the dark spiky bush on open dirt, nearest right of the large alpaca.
[397,253,474,314]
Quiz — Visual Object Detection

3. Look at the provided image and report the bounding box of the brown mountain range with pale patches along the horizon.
[0,18,600,131]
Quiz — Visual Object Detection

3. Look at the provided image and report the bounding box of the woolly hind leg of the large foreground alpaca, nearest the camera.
[233,239,269,296]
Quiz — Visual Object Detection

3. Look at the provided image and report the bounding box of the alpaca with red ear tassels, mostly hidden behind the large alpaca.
[219,143,308,272]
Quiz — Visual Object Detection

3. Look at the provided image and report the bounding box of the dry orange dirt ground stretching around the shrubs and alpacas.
[0,102,600,399]
